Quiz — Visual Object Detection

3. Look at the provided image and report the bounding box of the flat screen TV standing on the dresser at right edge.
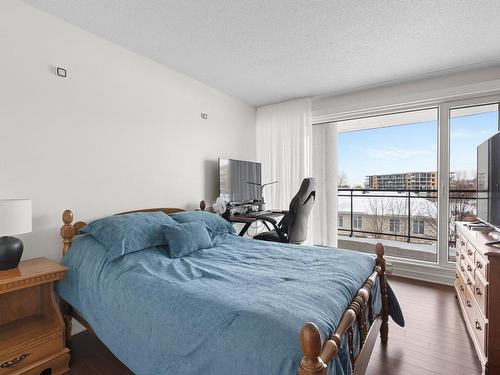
[477,132,500,229]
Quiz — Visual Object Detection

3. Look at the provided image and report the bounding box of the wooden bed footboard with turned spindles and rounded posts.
[297,243,389,375]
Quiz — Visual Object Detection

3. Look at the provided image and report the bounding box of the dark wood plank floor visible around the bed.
[67,277,481,375]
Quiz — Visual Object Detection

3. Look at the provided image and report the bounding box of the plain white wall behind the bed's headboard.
[0,0,255,260]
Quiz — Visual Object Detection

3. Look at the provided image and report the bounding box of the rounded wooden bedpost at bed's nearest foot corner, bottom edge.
[297,323,327,375]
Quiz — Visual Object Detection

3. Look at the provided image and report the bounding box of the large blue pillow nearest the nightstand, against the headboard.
[80,211,176,260]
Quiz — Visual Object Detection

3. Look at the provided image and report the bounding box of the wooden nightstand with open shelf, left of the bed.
[0,258,70,375]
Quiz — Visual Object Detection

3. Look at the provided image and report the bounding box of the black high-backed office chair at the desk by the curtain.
[253,177,316,244]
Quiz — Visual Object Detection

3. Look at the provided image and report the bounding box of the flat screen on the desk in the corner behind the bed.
[219,159,262,204]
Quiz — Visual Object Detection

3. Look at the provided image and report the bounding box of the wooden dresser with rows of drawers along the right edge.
[455,222,500,375]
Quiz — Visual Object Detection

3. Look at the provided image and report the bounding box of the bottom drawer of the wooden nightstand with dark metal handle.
[0,332,63,375]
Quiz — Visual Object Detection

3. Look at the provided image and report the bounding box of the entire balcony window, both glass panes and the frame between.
[313,96,500,269]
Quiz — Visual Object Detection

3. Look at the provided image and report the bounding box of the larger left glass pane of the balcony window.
[336,108,438,261]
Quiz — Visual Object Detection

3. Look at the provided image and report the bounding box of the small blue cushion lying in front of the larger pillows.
[161,221,212,258]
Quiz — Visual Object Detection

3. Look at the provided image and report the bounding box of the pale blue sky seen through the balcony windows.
[338,112,498,186]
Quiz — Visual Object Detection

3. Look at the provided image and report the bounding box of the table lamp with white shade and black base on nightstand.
[0,199,31,271]
